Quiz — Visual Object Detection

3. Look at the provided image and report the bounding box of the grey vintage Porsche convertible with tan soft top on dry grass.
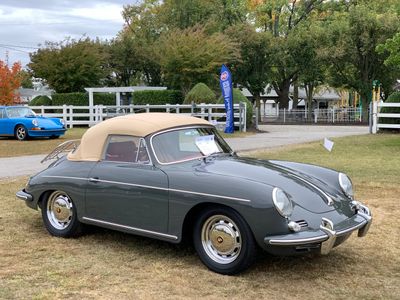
[17,113,372,274]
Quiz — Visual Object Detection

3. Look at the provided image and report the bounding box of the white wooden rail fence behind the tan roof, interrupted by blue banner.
[30,103,247,131]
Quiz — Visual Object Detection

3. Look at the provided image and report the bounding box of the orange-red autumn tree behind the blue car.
[0,60,21,105]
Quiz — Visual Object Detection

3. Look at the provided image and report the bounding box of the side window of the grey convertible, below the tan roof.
[104,135,150,164]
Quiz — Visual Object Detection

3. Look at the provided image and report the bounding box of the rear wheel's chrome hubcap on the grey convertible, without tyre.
[47,191,73,230]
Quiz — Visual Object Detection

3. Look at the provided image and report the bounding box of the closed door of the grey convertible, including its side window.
[85,135,168,233]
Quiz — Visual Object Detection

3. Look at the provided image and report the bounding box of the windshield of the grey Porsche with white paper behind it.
[152,127,232,164]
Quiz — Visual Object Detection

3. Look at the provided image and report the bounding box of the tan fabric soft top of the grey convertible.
[68,113,211,161]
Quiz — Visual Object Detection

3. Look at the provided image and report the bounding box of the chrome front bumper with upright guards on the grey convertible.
[264,203,372,254]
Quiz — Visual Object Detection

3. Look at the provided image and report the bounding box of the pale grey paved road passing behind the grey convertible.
[0,125,368,178]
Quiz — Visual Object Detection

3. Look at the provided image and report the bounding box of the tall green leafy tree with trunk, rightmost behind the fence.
[321,1,399,120]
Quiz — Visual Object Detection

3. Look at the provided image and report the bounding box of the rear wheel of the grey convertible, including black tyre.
[42,191,82,237]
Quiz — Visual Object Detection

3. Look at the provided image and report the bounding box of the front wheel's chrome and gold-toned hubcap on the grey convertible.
[201,215,242,264]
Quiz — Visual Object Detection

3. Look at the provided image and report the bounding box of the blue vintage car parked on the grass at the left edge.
[0,106,66,141]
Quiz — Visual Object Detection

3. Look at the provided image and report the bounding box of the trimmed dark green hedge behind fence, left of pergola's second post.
[52,93,115,106]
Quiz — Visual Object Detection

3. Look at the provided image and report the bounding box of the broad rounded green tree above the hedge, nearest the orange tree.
[28,38,108,93]
